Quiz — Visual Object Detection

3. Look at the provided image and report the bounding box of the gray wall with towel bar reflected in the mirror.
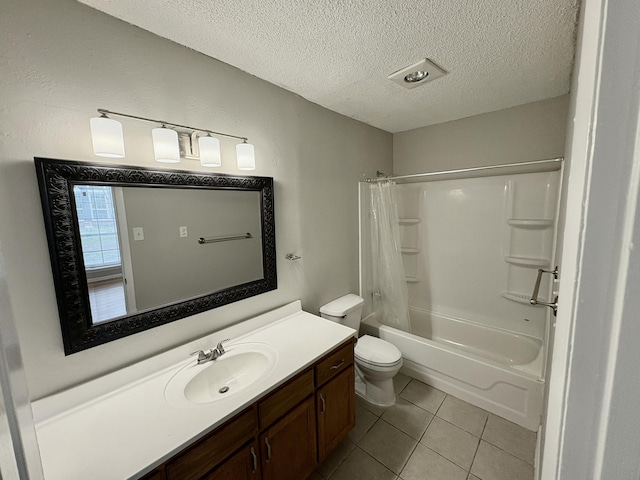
[118,188,263,310]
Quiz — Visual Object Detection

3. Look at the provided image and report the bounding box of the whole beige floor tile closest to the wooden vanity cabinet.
[358,420,418,473]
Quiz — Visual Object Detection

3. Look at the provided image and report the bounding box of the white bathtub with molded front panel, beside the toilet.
[361,307,544,431]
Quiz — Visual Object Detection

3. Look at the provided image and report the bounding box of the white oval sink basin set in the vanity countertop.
[165,343,278,406]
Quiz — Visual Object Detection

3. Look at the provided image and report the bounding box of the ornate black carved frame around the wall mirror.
[35,158,278,355]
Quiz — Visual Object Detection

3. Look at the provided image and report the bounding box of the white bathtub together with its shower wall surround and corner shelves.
[360,168,562,430]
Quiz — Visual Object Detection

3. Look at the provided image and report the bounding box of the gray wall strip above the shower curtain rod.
[393,95,569,175]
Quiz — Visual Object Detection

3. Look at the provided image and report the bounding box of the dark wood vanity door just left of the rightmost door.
[260,397,316,480]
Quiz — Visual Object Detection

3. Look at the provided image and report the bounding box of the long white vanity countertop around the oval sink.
[33,302,354,480]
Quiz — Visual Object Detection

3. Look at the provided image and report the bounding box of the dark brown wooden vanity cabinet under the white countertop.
[149,339,355,480]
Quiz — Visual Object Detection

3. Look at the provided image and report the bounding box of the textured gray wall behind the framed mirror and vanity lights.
[0,0,392,399]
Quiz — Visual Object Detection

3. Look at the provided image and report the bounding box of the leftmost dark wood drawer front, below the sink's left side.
[167,407,258,480]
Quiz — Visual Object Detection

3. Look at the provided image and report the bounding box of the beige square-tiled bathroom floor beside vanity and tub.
[308,374,536,480]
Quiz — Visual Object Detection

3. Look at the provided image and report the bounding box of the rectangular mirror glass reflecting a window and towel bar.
[73,184,263,323]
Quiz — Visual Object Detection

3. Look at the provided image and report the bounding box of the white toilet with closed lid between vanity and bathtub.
[320,293,402,407]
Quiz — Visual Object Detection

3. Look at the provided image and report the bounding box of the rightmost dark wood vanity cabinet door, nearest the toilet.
[316,365,356,462]
